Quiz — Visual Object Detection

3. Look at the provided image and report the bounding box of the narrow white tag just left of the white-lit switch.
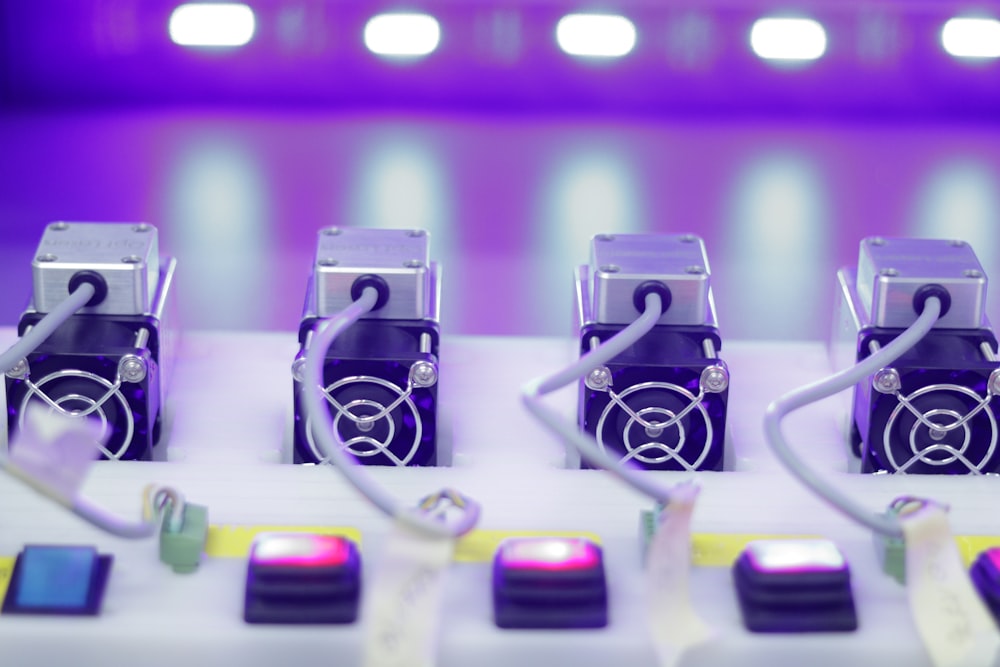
[646,484,712,667]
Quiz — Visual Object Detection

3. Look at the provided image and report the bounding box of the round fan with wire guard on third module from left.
[595,382,713,470]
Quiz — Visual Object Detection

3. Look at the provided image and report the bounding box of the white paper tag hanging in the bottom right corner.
[899,503,1000,667]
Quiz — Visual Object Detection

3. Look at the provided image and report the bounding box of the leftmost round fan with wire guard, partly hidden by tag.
[17,368,135,460]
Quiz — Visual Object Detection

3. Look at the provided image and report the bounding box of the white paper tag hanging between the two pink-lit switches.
[364,521,455,667]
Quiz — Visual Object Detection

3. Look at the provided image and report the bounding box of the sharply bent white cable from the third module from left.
[521,293,670,504]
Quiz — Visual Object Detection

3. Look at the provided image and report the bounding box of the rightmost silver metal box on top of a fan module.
[855,236,986,329]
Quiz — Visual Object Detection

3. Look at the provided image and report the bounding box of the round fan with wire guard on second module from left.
[305,375,424,466]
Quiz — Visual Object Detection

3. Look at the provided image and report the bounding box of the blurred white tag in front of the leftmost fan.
[9,405,100,499]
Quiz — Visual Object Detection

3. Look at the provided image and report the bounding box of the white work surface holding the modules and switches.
[0,329,1000,667]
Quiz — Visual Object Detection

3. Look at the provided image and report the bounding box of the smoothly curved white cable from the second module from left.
[302,287,479,537]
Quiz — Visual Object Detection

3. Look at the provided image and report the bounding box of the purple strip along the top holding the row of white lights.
[0,0,1000,119]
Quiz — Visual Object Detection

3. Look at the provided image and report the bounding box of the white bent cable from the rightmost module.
[764,297,941,537]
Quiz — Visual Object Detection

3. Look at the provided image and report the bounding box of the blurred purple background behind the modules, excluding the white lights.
[0,0,1000,339]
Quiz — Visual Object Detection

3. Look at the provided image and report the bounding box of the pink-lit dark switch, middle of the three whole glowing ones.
[493,537,608,629]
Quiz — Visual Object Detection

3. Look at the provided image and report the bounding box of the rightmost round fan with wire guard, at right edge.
[882,384,998,474]
